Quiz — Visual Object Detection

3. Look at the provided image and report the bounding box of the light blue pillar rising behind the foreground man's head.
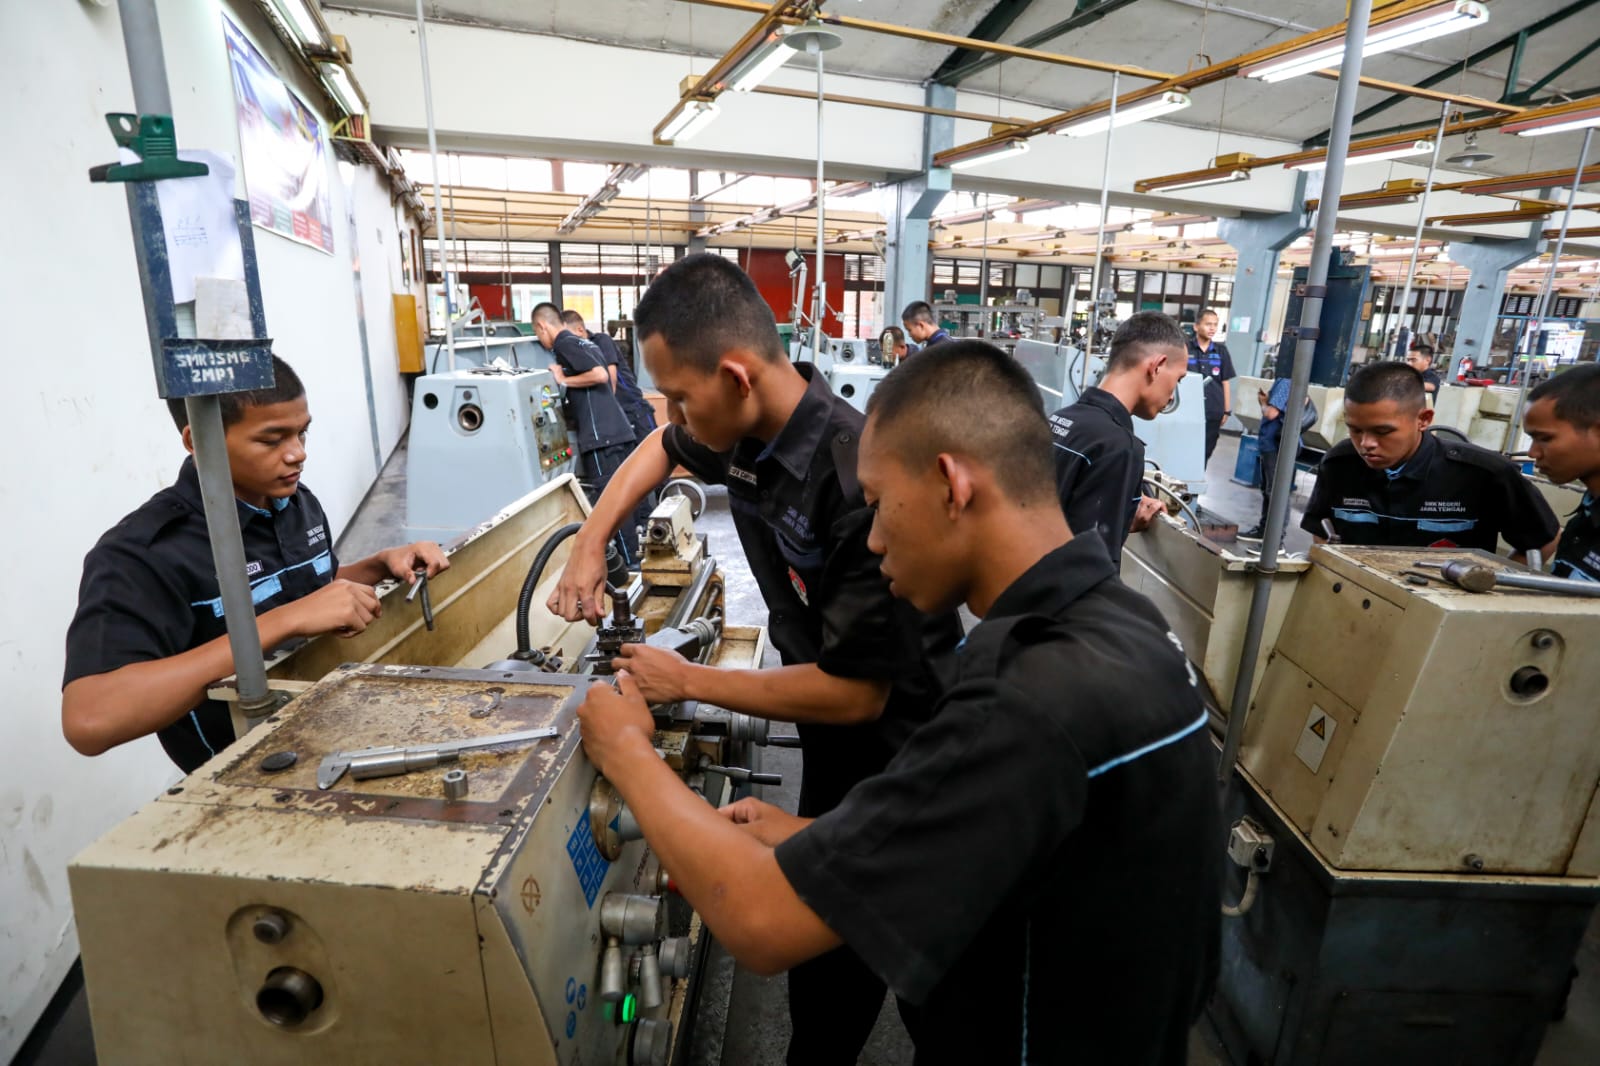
[883,85,955,325]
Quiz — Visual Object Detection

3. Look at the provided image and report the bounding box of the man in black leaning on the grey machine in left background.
[533,304,638,550]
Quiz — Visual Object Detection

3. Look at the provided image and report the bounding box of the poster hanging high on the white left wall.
[222,16,333,254]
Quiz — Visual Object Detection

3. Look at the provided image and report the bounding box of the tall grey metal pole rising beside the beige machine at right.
[1218,0,1373,783]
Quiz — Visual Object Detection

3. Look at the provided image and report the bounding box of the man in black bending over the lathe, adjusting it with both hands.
[549,254,962,1066]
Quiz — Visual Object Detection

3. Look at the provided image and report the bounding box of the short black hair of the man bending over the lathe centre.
[634,251,787,375]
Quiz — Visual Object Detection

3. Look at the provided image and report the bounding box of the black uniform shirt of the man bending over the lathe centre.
[661,363,962,815]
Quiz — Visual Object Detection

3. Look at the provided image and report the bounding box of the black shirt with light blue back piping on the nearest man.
[778,533,1222,1066]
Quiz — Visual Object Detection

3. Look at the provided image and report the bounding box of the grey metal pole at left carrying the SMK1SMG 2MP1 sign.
[118,0,272,717]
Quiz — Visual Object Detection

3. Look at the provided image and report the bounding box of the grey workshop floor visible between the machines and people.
[13,435,1600,1066]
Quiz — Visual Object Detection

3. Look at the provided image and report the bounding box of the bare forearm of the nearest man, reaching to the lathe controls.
[606,729,838,975]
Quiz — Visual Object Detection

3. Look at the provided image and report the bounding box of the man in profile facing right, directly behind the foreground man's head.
[1050,311,1189,565]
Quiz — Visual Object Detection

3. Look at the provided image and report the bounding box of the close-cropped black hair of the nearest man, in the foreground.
[867,339,1059,506]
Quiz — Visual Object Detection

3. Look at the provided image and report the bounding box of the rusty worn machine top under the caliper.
[214,664,587,824]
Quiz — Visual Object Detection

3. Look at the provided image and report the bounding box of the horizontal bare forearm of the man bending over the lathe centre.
[685,663,890,725]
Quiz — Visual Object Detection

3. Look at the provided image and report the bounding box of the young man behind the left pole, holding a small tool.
[61,357,450,773]
